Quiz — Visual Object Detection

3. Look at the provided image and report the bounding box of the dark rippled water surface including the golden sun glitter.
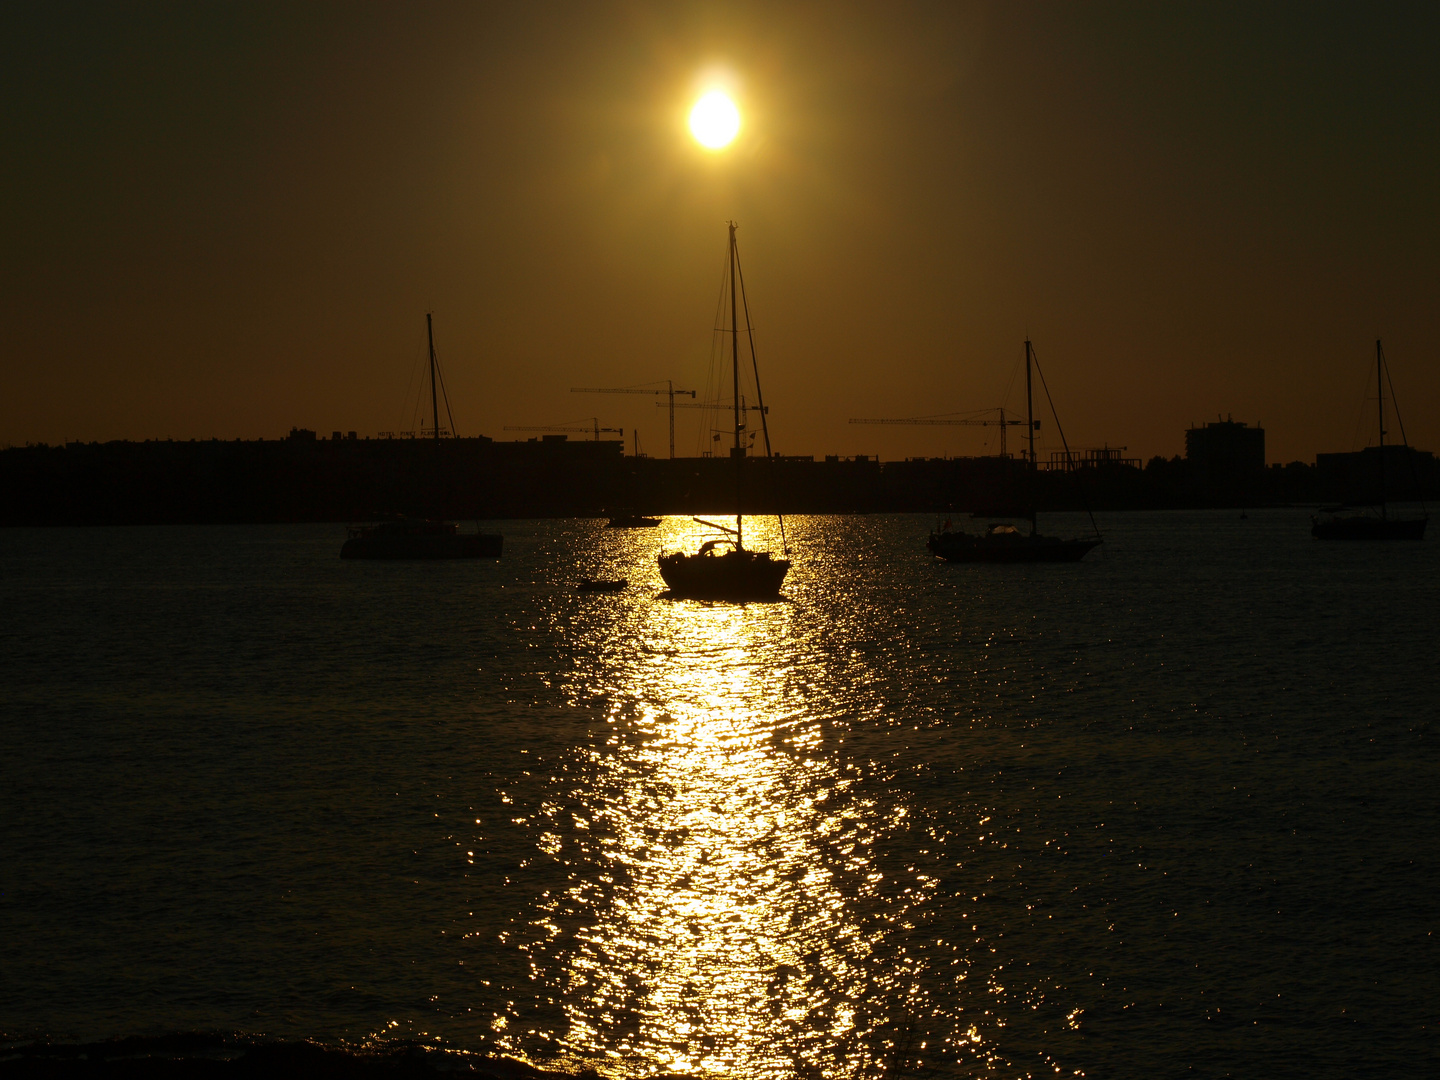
[0,511,1440,1077]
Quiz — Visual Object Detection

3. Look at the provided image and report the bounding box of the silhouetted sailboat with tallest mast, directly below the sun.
[660,222,791,600]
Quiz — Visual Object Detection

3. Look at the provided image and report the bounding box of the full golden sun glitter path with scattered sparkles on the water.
[475,516,1070,1080]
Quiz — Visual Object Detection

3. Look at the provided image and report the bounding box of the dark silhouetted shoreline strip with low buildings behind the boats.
[0,438,1422,526]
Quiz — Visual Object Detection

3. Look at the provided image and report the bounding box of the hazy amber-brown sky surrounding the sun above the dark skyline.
[0,0,1440,461]
